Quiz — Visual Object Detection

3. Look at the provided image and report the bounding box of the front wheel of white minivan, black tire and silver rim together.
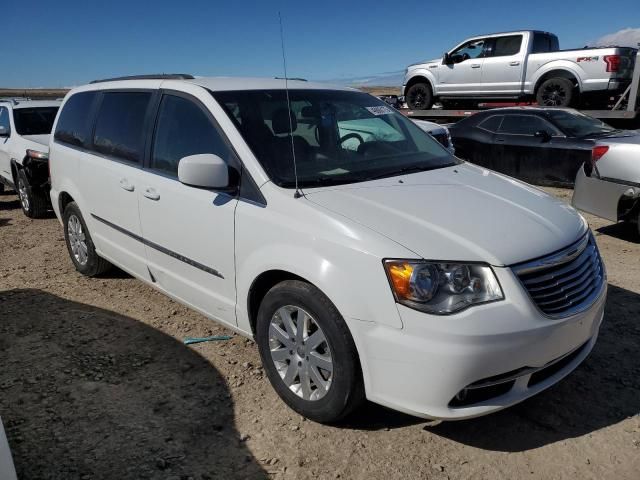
[256,280,364,423]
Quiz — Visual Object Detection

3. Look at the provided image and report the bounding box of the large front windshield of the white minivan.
[213,89,459,188]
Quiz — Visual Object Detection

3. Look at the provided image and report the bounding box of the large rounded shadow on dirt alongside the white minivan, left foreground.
[0,289,267,480]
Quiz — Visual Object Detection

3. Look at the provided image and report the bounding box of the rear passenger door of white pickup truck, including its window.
[481,34,527,95]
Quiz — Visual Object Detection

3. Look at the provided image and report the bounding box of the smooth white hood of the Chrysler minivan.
[305,164,587,266]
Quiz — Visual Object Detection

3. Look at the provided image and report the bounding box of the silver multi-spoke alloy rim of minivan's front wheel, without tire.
[269,305,333,401]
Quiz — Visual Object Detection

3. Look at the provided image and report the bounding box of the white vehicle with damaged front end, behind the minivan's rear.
[0,100,61,218]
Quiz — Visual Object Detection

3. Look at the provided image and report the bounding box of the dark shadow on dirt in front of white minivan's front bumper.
[425,285,640,452]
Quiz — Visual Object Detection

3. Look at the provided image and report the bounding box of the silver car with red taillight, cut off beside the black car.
[572,130,640,235]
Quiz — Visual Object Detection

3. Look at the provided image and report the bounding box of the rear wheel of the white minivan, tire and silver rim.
[62,202,111,277]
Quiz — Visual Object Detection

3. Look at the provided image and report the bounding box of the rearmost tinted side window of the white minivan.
[54,92,96,147]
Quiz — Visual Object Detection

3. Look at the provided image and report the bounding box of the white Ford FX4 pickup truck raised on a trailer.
[402,30,636,110]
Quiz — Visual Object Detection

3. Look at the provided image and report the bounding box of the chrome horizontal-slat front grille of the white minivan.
[511,232,605,317]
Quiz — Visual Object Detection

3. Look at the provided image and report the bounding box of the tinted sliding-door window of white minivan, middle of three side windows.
[93,92,151,163]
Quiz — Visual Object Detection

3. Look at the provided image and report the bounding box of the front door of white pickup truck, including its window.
[436,39,486,96]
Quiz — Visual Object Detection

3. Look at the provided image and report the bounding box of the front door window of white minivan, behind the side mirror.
[151,95,232,177]
